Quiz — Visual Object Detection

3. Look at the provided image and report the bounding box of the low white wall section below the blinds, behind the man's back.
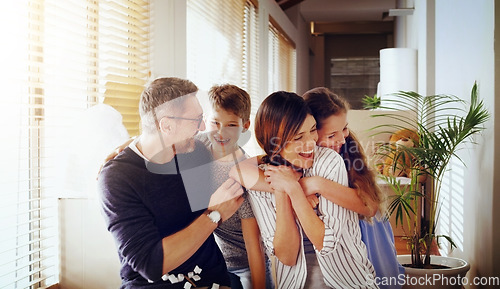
[59,198,121,289]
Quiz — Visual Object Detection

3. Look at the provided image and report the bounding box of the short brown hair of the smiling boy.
[208,84,251,123]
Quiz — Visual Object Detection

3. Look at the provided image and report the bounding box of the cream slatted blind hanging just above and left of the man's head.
[99,0,150,136]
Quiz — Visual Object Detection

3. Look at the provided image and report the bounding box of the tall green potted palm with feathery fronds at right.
[362,83,490,288]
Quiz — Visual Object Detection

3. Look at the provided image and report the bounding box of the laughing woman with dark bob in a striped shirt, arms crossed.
[231,91,378,288]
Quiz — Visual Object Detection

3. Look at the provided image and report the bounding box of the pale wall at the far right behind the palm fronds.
[435,0,499,284]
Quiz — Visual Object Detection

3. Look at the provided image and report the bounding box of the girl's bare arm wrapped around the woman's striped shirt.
[299,176,379,217]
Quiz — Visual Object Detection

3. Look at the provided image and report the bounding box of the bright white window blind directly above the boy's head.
[187,0,261,154]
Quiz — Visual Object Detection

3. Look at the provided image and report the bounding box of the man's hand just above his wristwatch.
[208,178,243,221]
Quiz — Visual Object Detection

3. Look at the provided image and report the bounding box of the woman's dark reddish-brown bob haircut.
[255,91,311,160]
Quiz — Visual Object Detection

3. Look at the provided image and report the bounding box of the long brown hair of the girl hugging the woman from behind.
[302,87,384,217]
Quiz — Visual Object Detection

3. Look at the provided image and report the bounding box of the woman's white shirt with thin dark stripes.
[249,147,378,289]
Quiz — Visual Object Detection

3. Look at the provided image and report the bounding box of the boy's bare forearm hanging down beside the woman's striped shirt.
[241,218,266,289]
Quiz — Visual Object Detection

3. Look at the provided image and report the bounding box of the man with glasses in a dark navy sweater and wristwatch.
[98,78,243,288]
